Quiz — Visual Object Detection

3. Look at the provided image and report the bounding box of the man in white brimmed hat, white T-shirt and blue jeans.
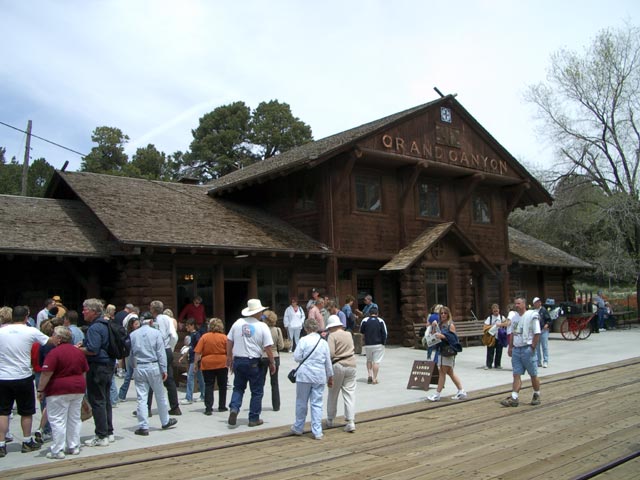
[227,298,276,427]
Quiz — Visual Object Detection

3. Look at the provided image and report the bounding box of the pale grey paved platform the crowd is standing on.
[0,328,640,472]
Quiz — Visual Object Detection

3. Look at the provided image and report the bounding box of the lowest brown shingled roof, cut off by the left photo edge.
[0,195,110,257]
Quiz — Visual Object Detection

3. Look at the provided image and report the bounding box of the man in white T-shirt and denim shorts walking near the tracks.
[500,298,540,407]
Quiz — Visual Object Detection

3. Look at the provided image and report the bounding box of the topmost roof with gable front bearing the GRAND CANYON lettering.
[208,95,552,206]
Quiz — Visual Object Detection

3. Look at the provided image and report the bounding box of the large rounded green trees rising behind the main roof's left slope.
[184,100,313,181]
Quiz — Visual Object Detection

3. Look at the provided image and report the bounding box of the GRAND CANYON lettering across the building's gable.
[382,133,509,175]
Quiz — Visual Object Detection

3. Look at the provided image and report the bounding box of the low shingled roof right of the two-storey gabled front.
[509,227,593,269]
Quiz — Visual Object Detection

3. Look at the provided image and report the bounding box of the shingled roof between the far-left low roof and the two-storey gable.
[47,172,329,253]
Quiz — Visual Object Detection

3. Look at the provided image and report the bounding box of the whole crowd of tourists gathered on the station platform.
[0,289,572,459]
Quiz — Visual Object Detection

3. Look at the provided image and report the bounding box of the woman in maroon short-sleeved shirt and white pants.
[38,326,89,460]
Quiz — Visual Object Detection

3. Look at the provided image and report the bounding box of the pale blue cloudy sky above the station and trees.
[0,0,640,170]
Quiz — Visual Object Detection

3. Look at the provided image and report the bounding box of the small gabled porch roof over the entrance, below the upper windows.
[380,222,497,273]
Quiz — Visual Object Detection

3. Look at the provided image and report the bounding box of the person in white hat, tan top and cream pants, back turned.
[326,315,356,433]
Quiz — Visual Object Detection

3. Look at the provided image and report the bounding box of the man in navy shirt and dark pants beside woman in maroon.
[81,298,116,447]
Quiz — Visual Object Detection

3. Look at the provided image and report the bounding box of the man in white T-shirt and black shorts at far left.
[0,306,56,458]
